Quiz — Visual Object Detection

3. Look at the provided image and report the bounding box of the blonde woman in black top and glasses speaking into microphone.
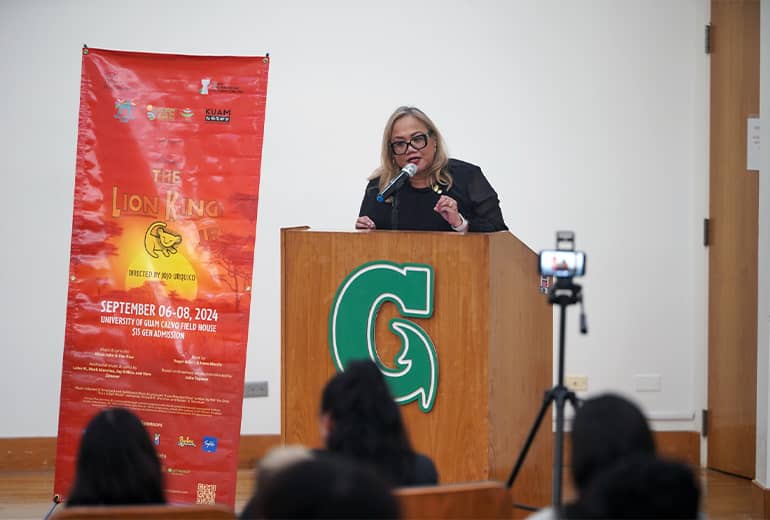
[356,106,508,233]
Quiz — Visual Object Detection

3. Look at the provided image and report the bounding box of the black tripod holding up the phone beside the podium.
[506,277,588,517]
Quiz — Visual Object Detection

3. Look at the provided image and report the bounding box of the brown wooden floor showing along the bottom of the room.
[0,470,752,519]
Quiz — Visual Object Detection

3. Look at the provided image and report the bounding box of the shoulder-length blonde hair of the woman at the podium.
[369,106,452,190]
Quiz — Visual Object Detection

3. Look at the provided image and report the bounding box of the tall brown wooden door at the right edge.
[708,0,759,478]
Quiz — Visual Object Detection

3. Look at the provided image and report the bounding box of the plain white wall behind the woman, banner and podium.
[0,0,708,437]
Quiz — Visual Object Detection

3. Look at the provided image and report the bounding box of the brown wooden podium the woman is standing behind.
[281,228,553,506]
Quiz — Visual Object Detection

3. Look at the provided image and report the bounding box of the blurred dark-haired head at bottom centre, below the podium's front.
[248,453,399,518]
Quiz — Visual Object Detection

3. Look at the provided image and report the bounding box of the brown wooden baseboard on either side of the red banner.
[0,435,281,471]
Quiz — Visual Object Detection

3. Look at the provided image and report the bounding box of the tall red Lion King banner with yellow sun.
[54,49,269,507]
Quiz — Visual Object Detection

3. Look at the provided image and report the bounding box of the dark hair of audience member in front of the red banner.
[67,408,166,506]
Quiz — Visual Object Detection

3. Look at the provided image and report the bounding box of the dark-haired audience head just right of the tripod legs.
[571,394,655,494]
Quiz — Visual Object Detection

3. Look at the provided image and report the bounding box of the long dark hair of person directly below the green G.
[321,360,415,486]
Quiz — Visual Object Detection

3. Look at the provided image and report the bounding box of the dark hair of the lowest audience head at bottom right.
[578,455,700,518]
